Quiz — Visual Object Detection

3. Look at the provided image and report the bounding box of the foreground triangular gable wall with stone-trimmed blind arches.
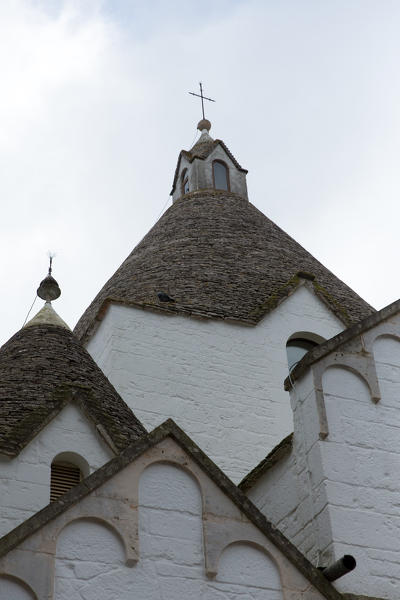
[0,438,323,600]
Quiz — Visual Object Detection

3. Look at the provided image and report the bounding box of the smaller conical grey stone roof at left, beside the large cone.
[0,306,146,456]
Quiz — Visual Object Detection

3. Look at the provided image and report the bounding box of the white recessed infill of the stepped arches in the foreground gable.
[55,463,283,600]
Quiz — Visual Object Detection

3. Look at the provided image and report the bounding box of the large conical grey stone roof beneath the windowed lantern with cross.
[75,190,374,341]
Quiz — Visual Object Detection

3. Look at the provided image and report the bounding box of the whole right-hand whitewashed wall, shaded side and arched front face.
[249,316,400,600]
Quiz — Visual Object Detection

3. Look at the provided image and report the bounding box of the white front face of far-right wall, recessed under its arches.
[321,337,400,598]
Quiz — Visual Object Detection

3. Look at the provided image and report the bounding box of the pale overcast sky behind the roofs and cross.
[0,0,400,343]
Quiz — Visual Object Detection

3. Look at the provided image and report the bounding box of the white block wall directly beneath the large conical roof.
[88,285,343,481]
